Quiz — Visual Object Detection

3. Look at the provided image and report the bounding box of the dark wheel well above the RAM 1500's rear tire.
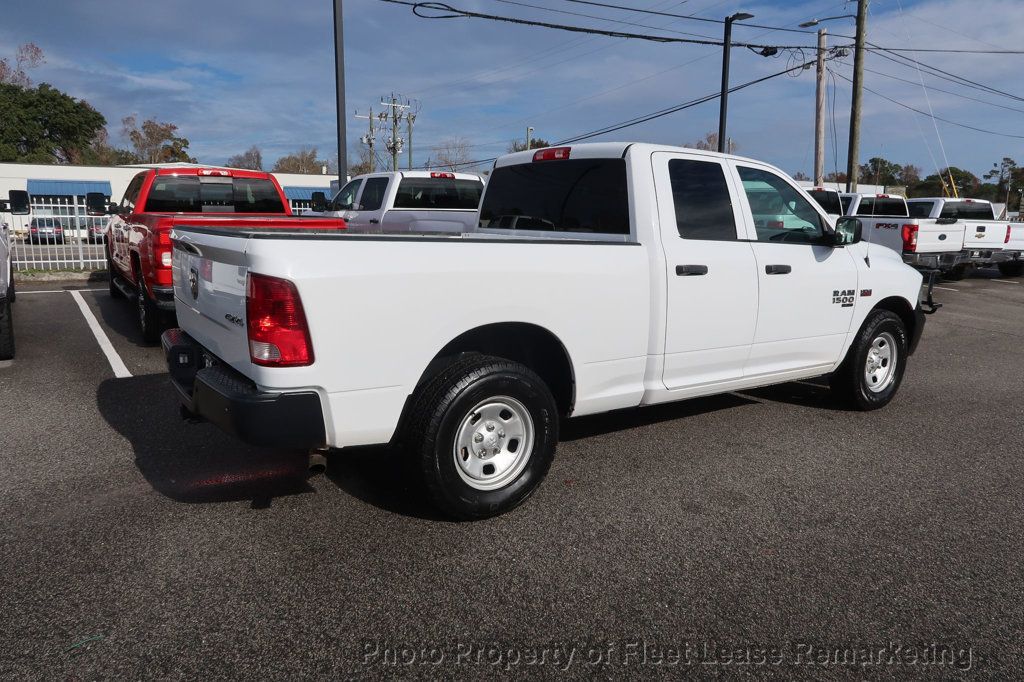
[417,323,575,415]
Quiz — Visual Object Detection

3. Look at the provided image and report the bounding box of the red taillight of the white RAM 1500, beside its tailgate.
[246,273,313,367]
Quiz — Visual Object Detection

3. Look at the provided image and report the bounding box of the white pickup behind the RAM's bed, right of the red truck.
[303,171,483,233]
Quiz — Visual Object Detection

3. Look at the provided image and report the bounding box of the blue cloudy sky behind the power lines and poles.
[0,0,1024,174]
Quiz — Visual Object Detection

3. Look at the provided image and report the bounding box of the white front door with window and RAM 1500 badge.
[730,162,860,377]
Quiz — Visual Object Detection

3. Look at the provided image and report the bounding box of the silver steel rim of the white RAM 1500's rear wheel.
[453,395,536,491]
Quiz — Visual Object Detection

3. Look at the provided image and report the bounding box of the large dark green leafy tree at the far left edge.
[0,83,106,164]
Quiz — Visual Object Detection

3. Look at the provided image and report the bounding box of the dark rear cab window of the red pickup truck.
[145,175,285,213]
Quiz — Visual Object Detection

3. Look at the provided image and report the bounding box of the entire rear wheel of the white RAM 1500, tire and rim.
[407,354,558,519]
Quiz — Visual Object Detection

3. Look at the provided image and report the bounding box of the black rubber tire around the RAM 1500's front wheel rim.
[830,310,908,411]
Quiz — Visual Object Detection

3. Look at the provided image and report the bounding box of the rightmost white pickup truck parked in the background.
[907,197,1022,279]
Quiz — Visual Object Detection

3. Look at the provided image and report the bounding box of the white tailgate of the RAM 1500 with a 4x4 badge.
[171,229,252,376]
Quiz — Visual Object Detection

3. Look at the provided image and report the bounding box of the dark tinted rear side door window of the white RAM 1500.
[669,159,736,242]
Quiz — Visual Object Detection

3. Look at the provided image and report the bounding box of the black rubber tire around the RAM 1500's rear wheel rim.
[402,354,558,520]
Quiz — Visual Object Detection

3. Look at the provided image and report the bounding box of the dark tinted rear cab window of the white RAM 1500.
[480,159,630,235]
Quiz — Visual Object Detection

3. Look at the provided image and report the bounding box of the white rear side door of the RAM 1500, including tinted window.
[652,152,758,390]
